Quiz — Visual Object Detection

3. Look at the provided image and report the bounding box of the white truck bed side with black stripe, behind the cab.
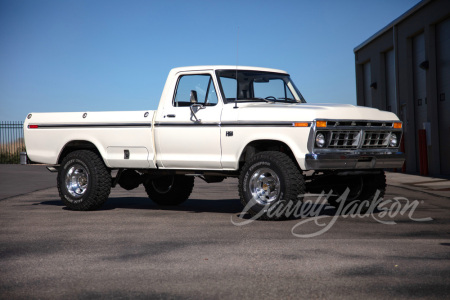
[24,110,156,168]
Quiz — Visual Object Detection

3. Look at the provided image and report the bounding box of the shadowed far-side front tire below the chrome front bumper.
[328,171,386,213]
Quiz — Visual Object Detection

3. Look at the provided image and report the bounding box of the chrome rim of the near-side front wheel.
[249,168,280,205]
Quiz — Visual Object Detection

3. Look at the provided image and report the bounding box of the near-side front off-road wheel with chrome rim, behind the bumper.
[239,151,305,220]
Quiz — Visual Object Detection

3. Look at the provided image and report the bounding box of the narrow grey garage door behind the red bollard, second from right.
[412,33,427,170]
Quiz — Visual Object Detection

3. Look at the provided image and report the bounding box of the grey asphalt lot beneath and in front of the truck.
[0,166,450,299]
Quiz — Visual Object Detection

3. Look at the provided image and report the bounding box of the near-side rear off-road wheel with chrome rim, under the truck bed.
[57,150,111,211]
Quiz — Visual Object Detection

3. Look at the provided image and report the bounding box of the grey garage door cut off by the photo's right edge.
[436,19,450,174]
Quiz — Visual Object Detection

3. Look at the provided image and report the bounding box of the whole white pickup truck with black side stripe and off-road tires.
[24,66,405,219]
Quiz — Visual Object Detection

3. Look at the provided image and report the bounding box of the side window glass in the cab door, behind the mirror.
[173,74,218,107]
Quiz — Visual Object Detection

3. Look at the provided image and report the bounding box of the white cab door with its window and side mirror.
[155,72,222,170]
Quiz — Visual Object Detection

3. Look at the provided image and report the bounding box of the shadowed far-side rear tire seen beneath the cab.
[144,175,194,206]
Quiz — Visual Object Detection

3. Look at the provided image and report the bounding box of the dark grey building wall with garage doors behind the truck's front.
[355,0,450,175]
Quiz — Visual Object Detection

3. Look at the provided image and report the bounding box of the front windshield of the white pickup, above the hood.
[216,70,306,103]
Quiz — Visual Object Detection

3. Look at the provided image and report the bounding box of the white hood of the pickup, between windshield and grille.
[234,102,398,121]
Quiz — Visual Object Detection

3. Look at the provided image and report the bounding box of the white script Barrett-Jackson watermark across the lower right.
[231,188,433,238]
